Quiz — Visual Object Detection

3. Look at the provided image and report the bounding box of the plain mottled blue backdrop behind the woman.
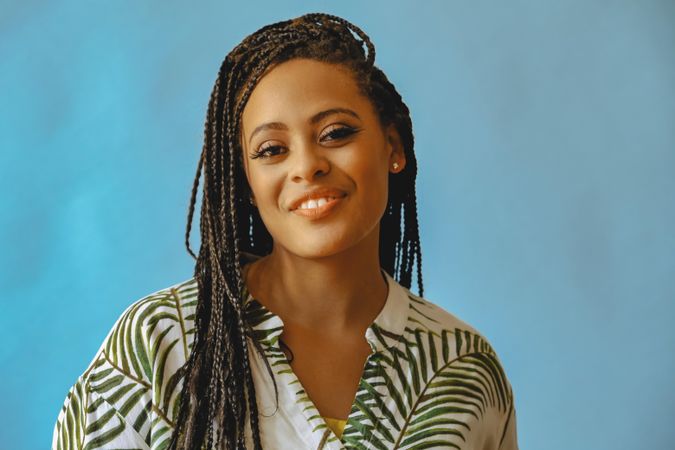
[0,0,675,449]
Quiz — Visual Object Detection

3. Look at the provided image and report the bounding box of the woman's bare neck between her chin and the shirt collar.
[245,229,388,334]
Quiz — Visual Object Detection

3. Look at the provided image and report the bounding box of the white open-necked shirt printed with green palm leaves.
[52,253,518,450]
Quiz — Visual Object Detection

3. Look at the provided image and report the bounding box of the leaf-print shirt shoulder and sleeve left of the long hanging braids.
[53,278,198,448]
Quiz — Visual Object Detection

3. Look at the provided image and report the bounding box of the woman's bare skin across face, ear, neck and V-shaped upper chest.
[241,59,405,418]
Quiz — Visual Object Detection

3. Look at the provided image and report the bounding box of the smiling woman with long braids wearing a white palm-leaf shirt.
[53,14,517,449]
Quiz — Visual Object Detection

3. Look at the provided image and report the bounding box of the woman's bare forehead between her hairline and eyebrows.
[242,58,371,136]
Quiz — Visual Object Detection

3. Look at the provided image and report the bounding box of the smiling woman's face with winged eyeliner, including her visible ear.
[241,59,405,258]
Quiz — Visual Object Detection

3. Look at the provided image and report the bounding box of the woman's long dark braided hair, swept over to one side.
[169,14,423,450]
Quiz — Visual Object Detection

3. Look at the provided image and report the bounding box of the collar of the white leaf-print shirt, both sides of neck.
[242,253,410,353]
